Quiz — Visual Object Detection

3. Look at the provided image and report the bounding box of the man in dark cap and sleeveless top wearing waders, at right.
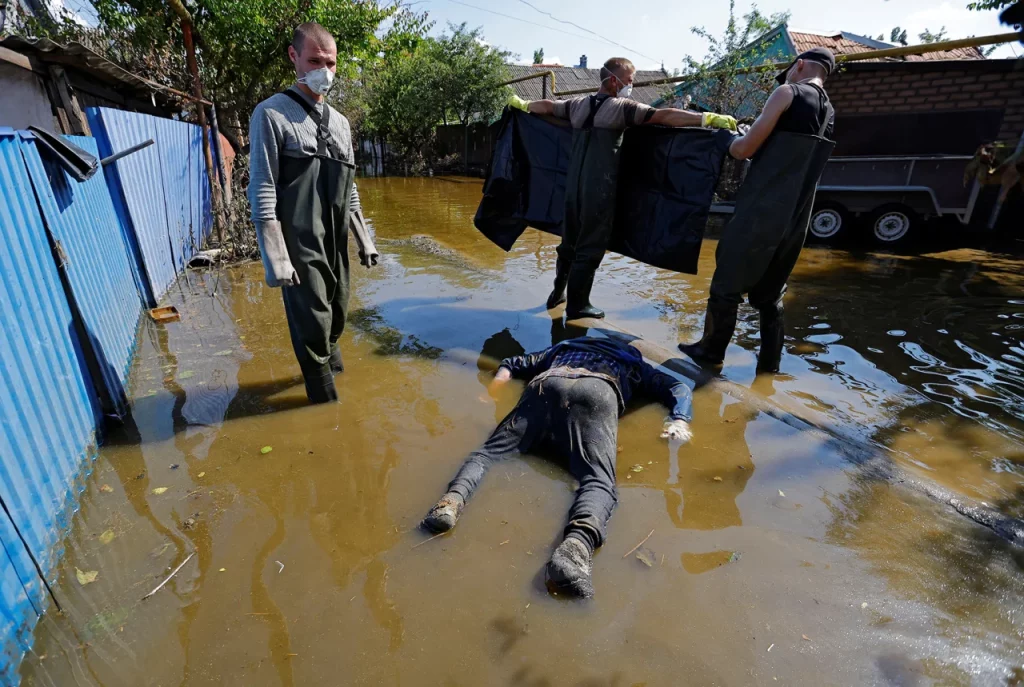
[679,48,836,373]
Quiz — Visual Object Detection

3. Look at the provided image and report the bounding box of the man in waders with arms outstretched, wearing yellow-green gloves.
[509,57,736,319]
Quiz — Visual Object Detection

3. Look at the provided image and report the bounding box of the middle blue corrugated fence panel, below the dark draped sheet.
[22,133,141,416]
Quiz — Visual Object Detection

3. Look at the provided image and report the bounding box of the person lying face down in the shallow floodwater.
[423,337,693,598]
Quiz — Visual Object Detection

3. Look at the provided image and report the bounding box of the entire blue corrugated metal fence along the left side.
[0,110,212,684]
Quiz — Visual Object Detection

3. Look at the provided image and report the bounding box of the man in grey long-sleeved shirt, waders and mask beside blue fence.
[249,23,378,403]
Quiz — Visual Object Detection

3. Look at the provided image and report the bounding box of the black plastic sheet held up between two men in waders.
[474,110,734,274]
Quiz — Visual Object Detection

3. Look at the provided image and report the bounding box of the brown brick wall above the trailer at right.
[826,59,1024,140]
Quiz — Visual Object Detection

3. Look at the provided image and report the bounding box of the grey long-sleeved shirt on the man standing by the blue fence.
[248,86,359,222]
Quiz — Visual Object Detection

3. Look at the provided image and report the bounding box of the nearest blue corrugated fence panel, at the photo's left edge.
[0,129,99,682]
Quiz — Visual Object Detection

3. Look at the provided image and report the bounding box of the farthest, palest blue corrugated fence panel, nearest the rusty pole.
[87,108,213,306]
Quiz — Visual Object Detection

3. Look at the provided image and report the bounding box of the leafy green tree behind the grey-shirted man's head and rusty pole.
[19,0,428,149]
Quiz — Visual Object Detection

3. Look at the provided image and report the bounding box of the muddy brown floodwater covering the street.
[23,179,1024,686]
